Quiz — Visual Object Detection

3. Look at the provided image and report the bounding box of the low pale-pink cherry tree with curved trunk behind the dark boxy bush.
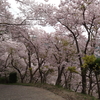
[0,41,28,82]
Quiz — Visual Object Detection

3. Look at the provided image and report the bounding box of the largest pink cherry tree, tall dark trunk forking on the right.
[17,0,100,93]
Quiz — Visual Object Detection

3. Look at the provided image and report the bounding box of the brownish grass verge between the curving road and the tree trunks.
[3,83,98,100]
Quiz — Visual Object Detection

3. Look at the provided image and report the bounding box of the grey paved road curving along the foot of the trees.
[0,85,65,100]
